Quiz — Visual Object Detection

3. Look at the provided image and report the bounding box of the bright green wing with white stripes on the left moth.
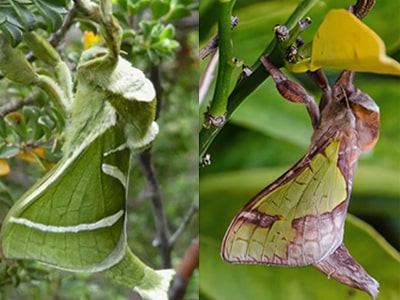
[2,126,129,272]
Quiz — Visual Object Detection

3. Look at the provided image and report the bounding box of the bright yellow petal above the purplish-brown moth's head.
[310,9,400,75]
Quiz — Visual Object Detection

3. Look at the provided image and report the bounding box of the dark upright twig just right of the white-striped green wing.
[138,148,171,268]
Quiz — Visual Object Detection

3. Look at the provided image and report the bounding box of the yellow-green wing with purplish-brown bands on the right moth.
[221,139,348,266]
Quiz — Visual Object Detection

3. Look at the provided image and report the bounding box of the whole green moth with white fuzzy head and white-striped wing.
[0,1,174,299]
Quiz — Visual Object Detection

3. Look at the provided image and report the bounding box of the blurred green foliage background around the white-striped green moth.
[0,0,198,300]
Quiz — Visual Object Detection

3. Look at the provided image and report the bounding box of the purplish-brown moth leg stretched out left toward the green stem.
[261,56,320,128]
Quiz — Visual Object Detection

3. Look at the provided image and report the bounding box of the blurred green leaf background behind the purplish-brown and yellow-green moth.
[199,0,400,300]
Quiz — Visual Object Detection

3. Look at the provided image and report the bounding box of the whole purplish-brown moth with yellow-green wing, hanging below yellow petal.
[221,57,380,299]
